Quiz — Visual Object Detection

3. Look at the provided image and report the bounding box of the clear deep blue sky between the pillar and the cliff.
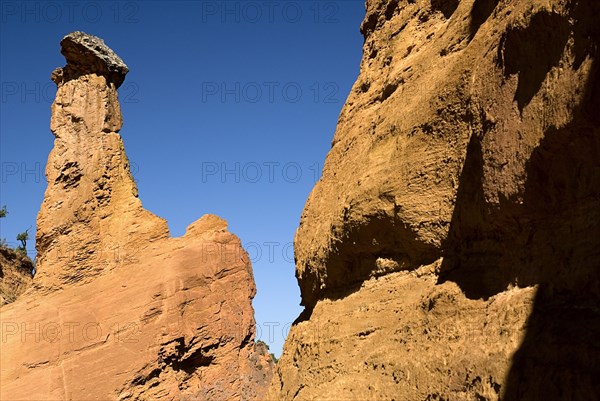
[0,0,364,354]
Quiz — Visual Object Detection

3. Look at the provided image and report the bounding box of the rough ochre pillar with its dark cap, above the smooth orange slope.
[35,32,169,291]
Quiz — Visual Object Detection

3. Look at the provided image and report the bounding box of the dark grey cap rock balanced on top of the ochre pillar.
[51,31,129,88]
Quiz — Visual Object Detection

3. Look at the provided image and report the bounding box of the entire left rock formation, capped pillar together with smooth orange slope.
[0,32,273,400]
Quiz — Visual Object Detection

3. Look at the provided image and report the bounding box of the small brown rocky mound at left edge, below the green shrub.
[0,246,33,306]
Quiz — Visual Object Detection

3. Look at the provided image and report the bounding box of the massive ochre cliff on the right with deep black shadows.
[268,0,600,401]
